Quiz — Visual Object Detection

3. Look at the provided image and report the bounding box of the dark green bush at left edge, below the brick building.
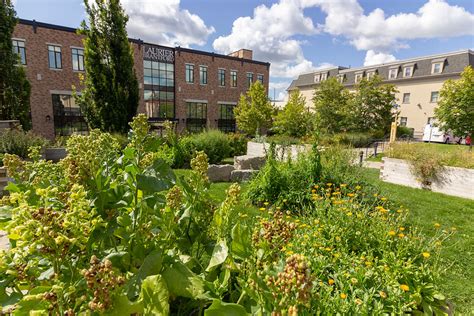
[0,129,48,158]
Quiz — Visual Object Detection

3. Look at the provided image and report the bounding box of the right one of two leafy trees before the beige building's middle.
[349,76,397,133]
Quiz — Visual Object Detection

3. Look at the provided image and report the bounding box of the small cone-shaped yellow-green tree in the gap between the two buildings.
[273,90,312,137]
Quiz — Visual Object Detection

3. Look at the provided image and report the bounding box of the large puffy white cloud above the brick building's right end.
[213,0,318,78]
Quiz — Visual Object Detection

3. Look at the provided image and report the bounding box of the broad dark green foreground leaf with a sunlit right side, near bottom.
[162,261,204,299]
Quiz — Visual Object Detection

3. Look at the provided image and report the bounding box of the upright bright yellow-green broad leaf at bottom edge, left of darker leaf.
[141,274,170,316]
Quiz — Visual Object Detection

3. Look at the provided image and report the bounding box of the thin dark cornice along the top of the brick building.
[18,19,270,67]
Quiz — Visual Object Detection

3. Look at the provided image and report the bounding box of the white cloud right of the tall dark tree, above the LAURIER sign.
[121,0,215,47]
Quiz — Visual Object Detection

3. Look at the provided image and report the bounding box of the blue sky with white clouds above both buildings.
[14,0,474,99]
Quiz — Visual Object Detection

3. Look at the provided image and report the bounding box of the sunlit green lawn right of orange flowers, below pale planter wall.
[366,168,474,315]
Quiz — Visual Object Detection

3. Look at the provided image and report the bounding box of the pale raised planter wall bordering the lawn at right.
[380,157,474,199]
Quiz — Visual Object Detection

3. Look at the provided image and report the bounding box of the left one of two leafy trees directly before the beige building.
[313,77,351,133]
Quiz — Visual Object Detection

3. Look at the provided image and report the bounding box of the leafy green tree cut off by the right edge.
[435,66,474,137]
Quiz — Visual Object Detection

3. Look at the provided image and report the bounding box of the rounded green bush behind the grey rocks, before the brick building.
[179,130,231,165]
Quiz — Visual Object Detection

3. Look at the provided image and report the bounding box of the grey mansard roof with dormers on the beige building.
[287,49,474,91]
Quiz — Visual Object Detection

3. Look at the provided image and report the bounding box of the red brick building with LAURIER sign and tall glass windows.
[12,19,270,139]
